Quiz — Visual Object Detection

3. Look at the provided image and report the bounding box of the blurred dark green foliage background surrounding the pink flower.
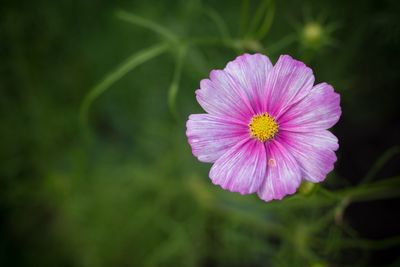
[0,0,400,267]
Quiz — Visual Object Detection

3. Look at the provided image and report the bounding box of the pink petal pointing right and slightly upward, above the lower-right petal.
[278,83,341,132]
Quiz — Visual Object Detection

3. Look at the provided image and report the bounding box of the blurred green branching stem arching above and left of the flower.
[81,0,275,126]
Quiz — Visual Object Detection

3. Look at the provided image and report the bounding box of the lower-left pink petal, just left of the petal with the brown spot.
[210,139,266,194]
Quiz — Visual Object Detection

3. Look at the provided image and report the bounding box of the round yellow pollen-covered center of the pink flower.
[249,112,279,142]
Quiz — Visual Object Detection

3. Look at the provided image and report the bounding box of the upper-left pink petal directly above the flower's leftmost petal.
[196,70,254,123]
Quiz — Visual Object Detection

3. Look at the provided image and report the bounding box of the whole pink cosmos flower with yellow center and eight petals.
[186,54,341,201]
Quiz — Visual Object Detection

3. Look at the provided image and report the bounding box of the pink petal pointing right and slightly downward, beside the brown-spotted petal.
[279,130,339,182]
